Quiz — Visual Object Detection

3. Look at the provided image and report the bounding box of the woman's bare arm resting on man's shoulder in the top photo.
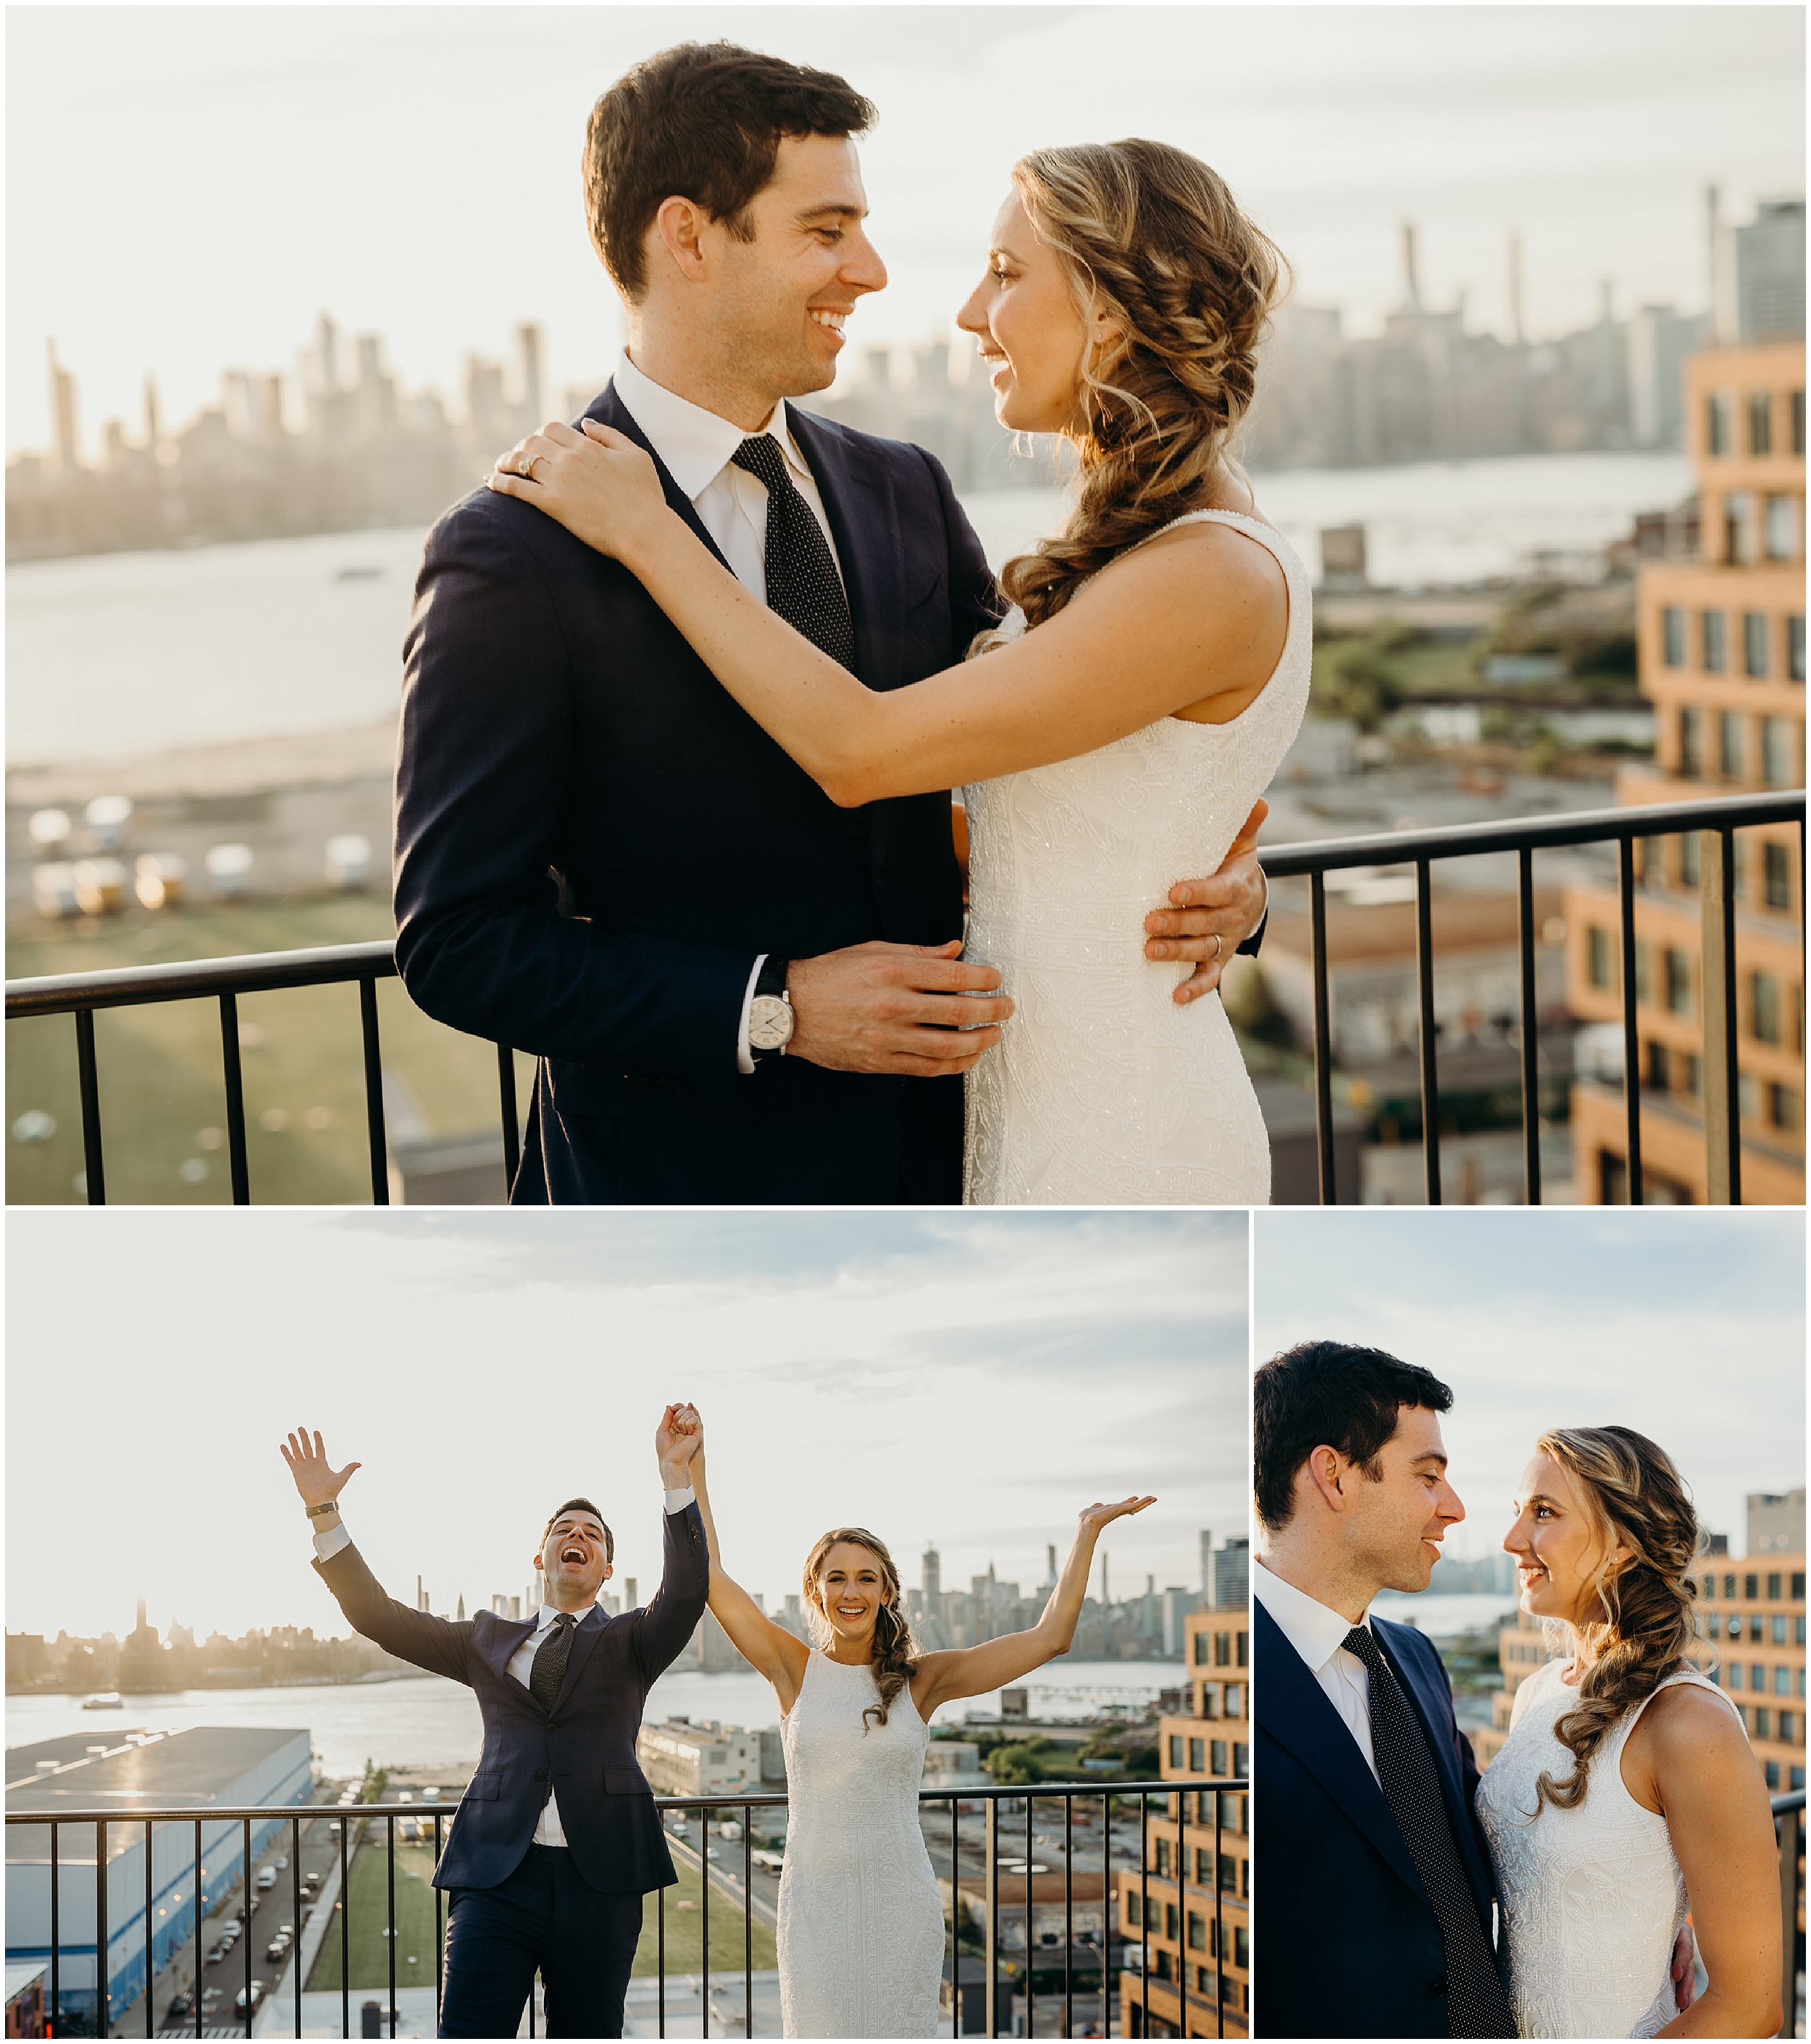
[487,419,1288,808]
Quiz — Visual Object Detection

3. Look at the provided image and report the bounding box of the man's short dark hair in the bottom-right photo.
[1251,1341,1453,1533]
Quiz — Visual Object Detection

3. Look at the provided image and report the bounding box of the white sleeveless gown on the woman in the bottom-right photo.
[1478,1662,1736,2038]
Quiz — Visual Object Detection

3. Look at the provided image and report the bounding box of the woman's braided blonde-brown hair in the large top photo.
[1000,141,1288,627]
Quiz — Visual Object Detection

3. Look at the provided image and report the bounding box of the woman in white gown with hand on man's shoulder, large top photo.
[487,141,1313,1206]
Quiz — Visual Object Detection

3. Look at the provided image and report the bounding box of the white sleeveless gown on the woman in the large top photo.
[963,511,1314,1206]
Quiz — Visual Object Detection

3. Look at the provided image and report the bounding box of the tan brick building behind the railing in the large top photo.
[1565,339,1805,1204]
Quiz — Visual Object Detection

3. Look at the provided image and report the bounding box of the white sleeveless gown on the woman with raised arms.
[779,1649,945,2038]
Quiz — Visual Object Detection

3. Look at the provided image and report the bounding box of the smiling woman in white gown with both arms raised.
[674,1410,1155,2038]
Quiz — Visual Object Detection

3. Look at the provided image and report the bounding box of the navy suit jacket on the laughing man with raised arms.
[315,1504,709,1895]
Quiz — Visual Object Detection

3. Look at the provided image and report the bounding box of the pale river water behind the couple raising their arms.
[6,1662,1186,1774]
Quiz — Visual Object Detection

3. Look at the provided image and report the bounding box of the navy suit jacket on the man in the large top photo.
[395,385,1000,1204]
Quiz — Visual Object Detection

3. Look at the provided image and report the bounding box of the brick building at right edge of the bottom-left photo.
[1116,1604,1251,2038]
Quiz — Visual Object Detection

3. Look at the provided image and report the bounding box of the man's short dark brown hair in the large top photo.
[585,43,875,301]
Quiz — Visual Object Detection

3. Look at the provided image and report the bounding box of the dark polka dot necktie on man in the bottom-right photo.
[1343,1625,1517,2038]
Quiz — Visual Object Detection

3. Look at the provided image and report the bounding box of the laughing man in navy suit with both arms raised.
[282,1407,709,2038]
